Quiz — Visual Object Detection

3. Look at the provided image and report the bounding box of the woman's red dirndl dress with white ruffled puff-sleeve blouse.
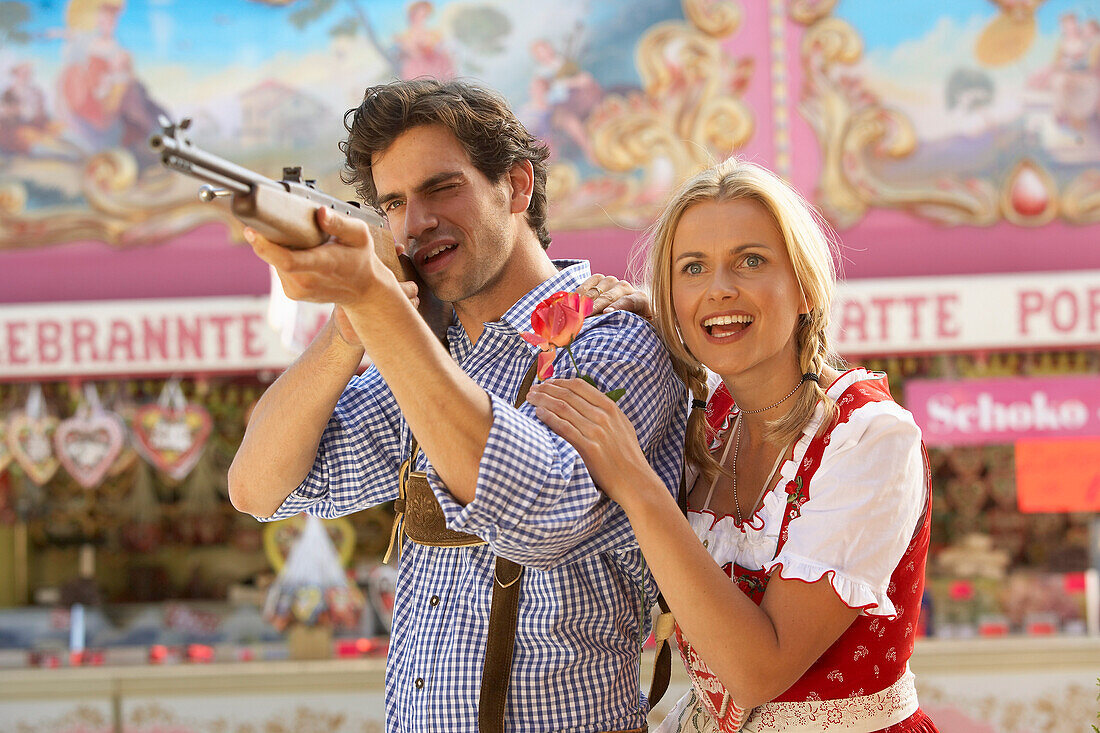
[657,369,936,733]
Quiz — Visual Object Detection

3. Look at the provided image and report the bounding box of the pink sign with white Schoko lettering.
[905,375,1100,446]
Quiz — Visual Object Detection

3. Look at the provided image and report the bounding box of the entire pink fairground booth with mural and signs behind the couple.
[0,0,1100,733]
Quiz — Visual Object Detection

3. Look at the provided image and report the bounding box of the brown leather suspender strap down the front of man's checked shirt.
[477,362,538,733]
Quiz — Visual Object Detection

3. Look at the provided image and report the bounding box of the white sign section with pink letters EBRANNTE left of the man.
[0,296,328,379]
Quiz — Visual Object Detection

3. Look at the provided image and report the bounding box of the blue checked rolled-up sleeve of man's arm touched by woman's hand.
[428,313,686,568]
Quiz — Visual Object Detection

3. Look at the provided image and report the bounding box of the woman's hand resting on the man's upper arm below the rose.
[527,379,663,508]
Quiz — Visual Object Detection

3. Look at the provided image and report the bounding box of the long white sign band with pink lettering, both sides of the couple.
[0,265,1100,379]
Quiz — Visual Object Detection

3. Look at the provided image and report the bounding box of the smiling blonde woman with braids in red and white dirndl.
[528,160,936,733]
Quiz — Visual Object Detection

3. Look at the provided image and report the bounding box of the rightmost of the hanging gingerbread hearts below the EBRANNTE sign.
[133,404,212,481]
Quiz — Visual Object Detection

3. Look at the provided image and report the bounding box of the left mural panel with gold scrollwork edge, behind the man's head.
[0,0,751,249]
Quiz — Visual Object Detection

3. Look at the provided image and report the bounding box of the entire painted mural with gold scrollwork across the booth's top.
[0,0,1100,256]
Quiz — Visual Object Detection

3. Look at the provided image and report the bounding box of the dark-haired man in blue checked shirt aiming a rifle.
[230,80,686,733]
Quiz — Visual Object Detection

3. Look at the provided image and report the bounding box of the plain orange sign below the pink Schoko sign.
[1015,438,1100,512]
